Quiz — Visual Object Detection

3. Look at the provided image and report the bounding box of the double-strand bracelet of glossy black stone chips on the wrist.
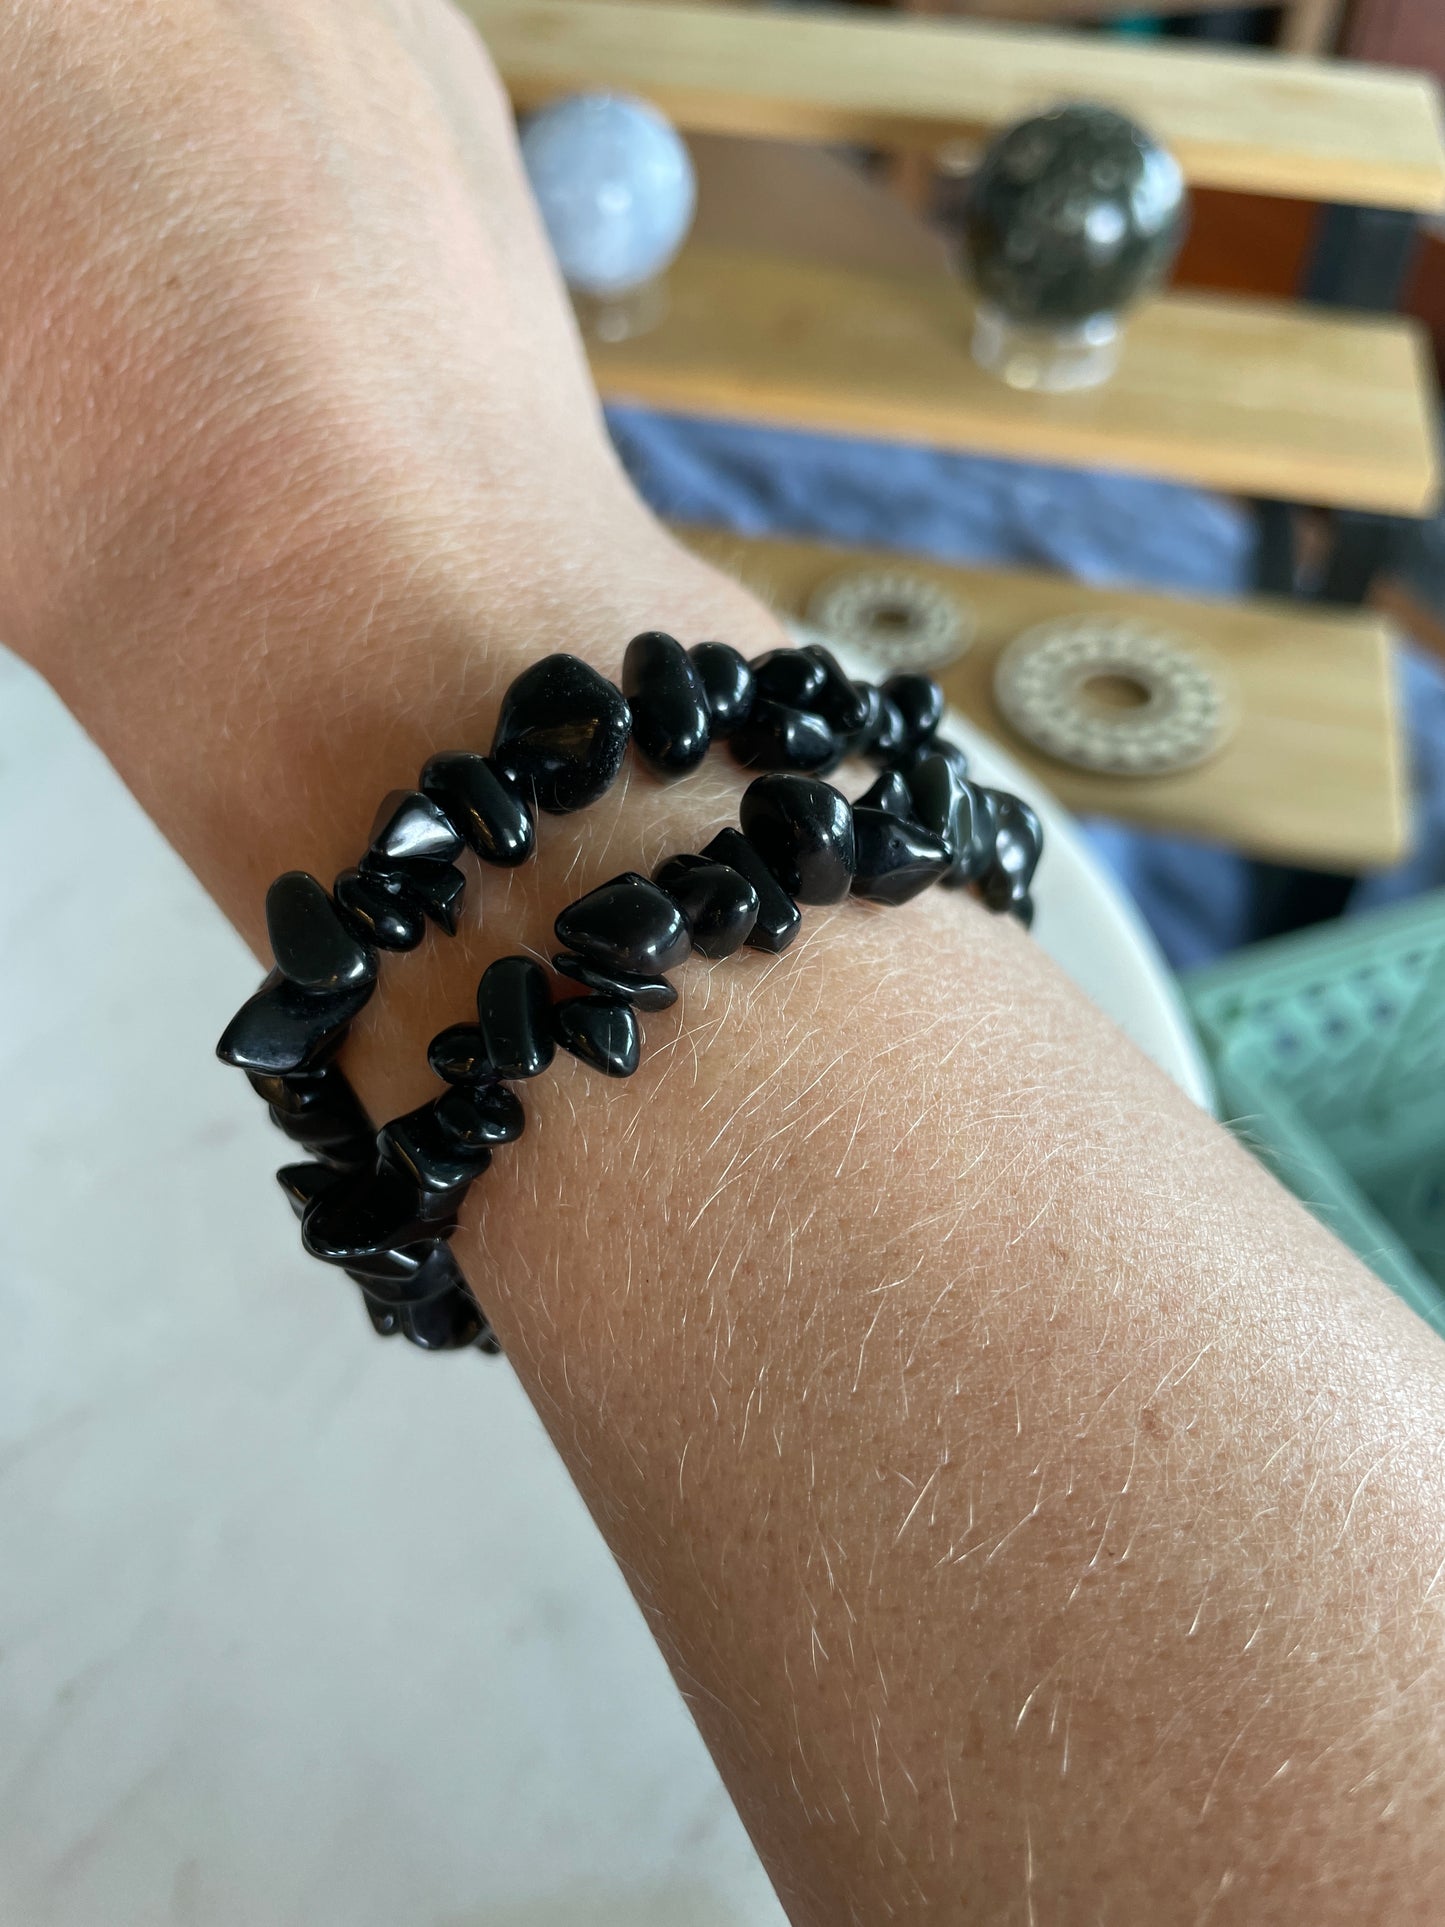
[216,632,1042,1353]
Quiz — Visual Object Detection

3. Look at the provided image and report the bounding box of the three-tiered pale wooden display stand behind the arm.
[497,0,1445,879]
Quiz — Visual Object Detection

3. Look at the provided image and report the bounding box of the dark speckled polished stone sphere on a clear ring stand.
[963,104,1189,328]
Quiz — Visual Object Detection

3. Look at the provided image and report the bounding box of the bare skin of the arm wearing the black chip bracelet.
[0,0,1445,1927]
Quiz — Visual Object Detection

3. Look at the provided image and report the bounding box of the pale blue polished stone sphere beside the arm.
[522,94,697,297]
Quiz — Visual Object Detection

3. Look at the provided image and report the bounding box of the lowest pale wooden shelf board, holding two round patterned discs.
[680,528,1406,871]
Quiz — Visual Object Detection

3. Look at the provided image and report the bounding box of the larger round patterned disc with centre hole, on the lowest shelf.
[994,617,1233,777]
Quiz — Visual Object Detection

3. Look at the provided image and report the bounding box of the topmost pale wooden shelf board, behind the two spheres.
[462,0,1445,210]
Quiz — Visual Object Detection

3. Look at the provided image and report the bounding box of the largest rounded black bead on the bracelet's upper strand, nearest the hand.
[491,655,632,815]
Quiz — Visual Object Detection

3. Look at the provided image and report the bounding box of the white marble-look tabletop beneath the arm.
[0,639,1195,1927]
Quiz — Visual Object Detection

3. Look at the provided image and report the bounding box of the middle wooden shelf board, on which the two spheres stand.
[591,243,1437,515]
